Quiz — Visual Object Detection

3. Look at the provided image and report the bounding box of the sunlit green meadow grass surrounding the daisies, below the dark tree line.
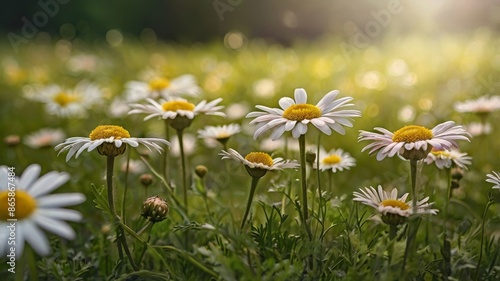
[0,29,500,280]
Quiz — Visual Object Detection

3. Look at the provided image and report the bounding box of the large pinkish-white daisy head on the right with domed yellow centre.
[358,121,470,161]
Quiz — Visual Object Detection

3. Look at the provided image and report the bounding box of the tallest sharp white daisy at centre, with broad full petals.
[247,88,361,140]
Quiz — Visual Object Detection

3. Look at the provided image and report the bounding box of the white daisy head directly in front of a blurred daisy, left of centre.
[128,98,226,129]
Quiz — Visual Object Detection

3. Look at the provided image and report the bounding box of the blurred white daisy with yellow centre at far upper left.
[25,81,102,118]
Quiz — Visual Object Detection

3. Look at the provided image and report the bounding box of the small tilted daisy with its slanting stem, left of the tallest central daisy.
[219,148,300,229]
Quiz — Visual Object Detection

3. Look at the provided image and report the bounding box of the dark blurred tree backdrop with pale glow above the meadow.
[0,0,500,44]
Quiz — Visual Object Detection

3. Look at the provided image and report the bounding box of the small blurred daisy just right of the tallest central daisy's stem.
[314,147,356,173]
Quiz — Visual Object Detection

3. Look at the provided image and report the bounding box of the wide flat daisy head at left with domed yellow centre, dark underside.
[55,125,170,162]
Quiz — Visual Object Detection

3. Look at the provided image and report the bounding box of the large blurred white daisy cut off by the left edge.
[0,164,85,257]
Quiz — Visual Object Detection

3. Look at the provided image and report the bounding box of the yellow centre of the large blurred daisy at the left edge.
[0,190,36,221]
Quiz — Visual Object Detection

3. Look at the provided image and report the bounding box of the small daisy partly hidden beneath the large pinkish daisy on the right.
[424,148,472,169]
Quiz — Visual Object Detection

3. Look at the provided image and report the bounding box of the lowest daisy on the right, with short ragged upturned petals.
[353,185,439,225]
